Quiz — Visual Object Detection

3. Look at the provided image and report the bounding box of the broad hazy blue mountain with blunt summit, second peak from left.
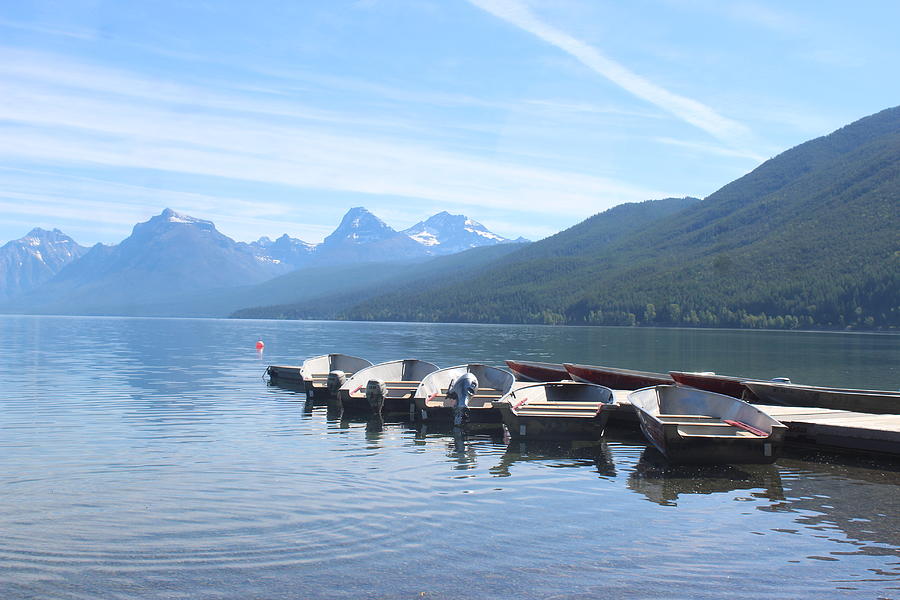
[7,208,287,314]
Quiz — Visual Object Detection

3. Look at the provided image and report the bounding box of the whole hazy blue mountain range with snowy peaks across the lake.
[0,207,524,315]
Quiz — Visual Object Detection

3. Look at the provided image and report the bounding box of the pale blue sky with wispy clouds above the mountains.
[0,0,900,245]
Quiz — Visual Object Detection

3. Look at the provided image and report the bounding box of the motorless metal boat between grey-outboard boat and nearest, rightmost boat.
[494,381,615,440]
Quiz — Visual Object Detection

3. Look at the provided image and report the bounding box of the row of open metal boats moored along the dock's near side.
[267,354,808,463]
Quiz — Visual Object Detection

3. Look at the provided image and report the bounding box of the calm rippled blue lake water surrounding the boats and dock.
[0,317,900,599]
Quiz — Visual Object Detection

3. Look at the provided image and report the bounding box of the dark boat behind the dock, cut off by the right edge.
[741,380,900,415]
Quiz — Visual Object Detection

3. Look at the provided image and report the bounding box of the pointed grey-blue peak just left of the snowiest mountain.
[315,206,428,264]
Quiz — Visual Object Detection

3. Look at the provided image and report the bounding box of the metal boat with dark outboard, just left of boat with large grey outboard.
[338,358,440,413]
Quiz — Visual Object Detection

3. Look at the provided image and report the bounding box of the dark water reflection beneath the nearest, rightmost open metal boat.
[627,446,784,506]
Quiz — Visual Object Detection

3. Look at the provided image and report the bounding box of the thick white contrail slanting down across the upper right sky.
[469,0,750,146]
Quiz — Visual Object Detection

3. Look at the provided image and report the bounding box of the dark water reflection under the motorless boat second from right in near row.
[490,440,616,477]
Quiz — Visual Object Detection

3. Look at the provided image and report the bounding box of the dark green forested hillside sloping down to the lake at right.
[338,108,900,329]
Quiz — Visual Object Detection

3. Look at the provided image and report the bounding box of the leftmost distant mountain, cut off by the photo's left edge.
[0,227,88,301]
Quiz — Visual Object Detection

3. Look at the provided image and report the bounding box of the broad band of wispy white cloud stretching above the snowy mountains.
[0,51,663,241]
